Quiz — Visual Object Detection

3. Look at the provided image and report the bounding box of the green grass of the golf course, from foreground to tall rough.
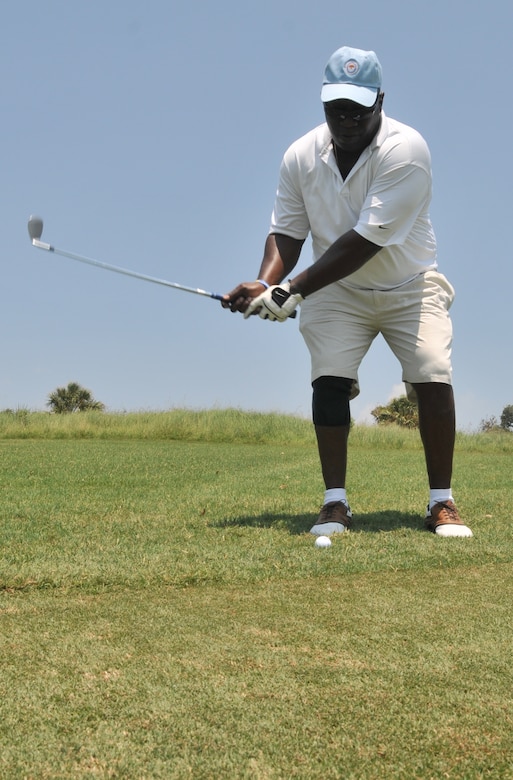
[0,414,513,780]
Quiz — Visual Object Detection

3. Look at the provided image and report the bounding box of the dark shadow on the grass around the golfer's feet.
[211,510,424,534]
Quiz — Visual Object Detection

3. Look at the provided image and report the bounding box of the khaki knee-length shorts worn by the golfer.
[300,271,454,399]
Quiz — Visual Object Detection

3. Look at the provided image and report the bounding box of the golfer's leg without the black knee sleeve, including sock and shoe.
[413,382,472,536]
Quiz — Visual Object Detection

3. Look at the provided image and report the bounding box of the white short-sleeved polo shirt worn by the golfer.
[270,113,437,290]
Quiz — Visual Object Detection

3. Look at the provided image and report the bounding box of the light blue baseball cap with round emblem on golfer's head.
[321,46,382,107]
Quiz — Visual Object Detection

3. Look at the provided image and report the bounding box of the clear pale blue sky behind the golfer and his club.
[0,0,513,430]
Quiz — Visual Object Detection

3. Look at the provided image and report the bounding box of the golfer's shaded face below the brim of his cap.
[324,93,384,152]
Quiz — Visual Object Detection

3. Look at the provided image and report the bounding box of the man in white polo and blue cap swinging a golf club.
[223,46,472,536]
